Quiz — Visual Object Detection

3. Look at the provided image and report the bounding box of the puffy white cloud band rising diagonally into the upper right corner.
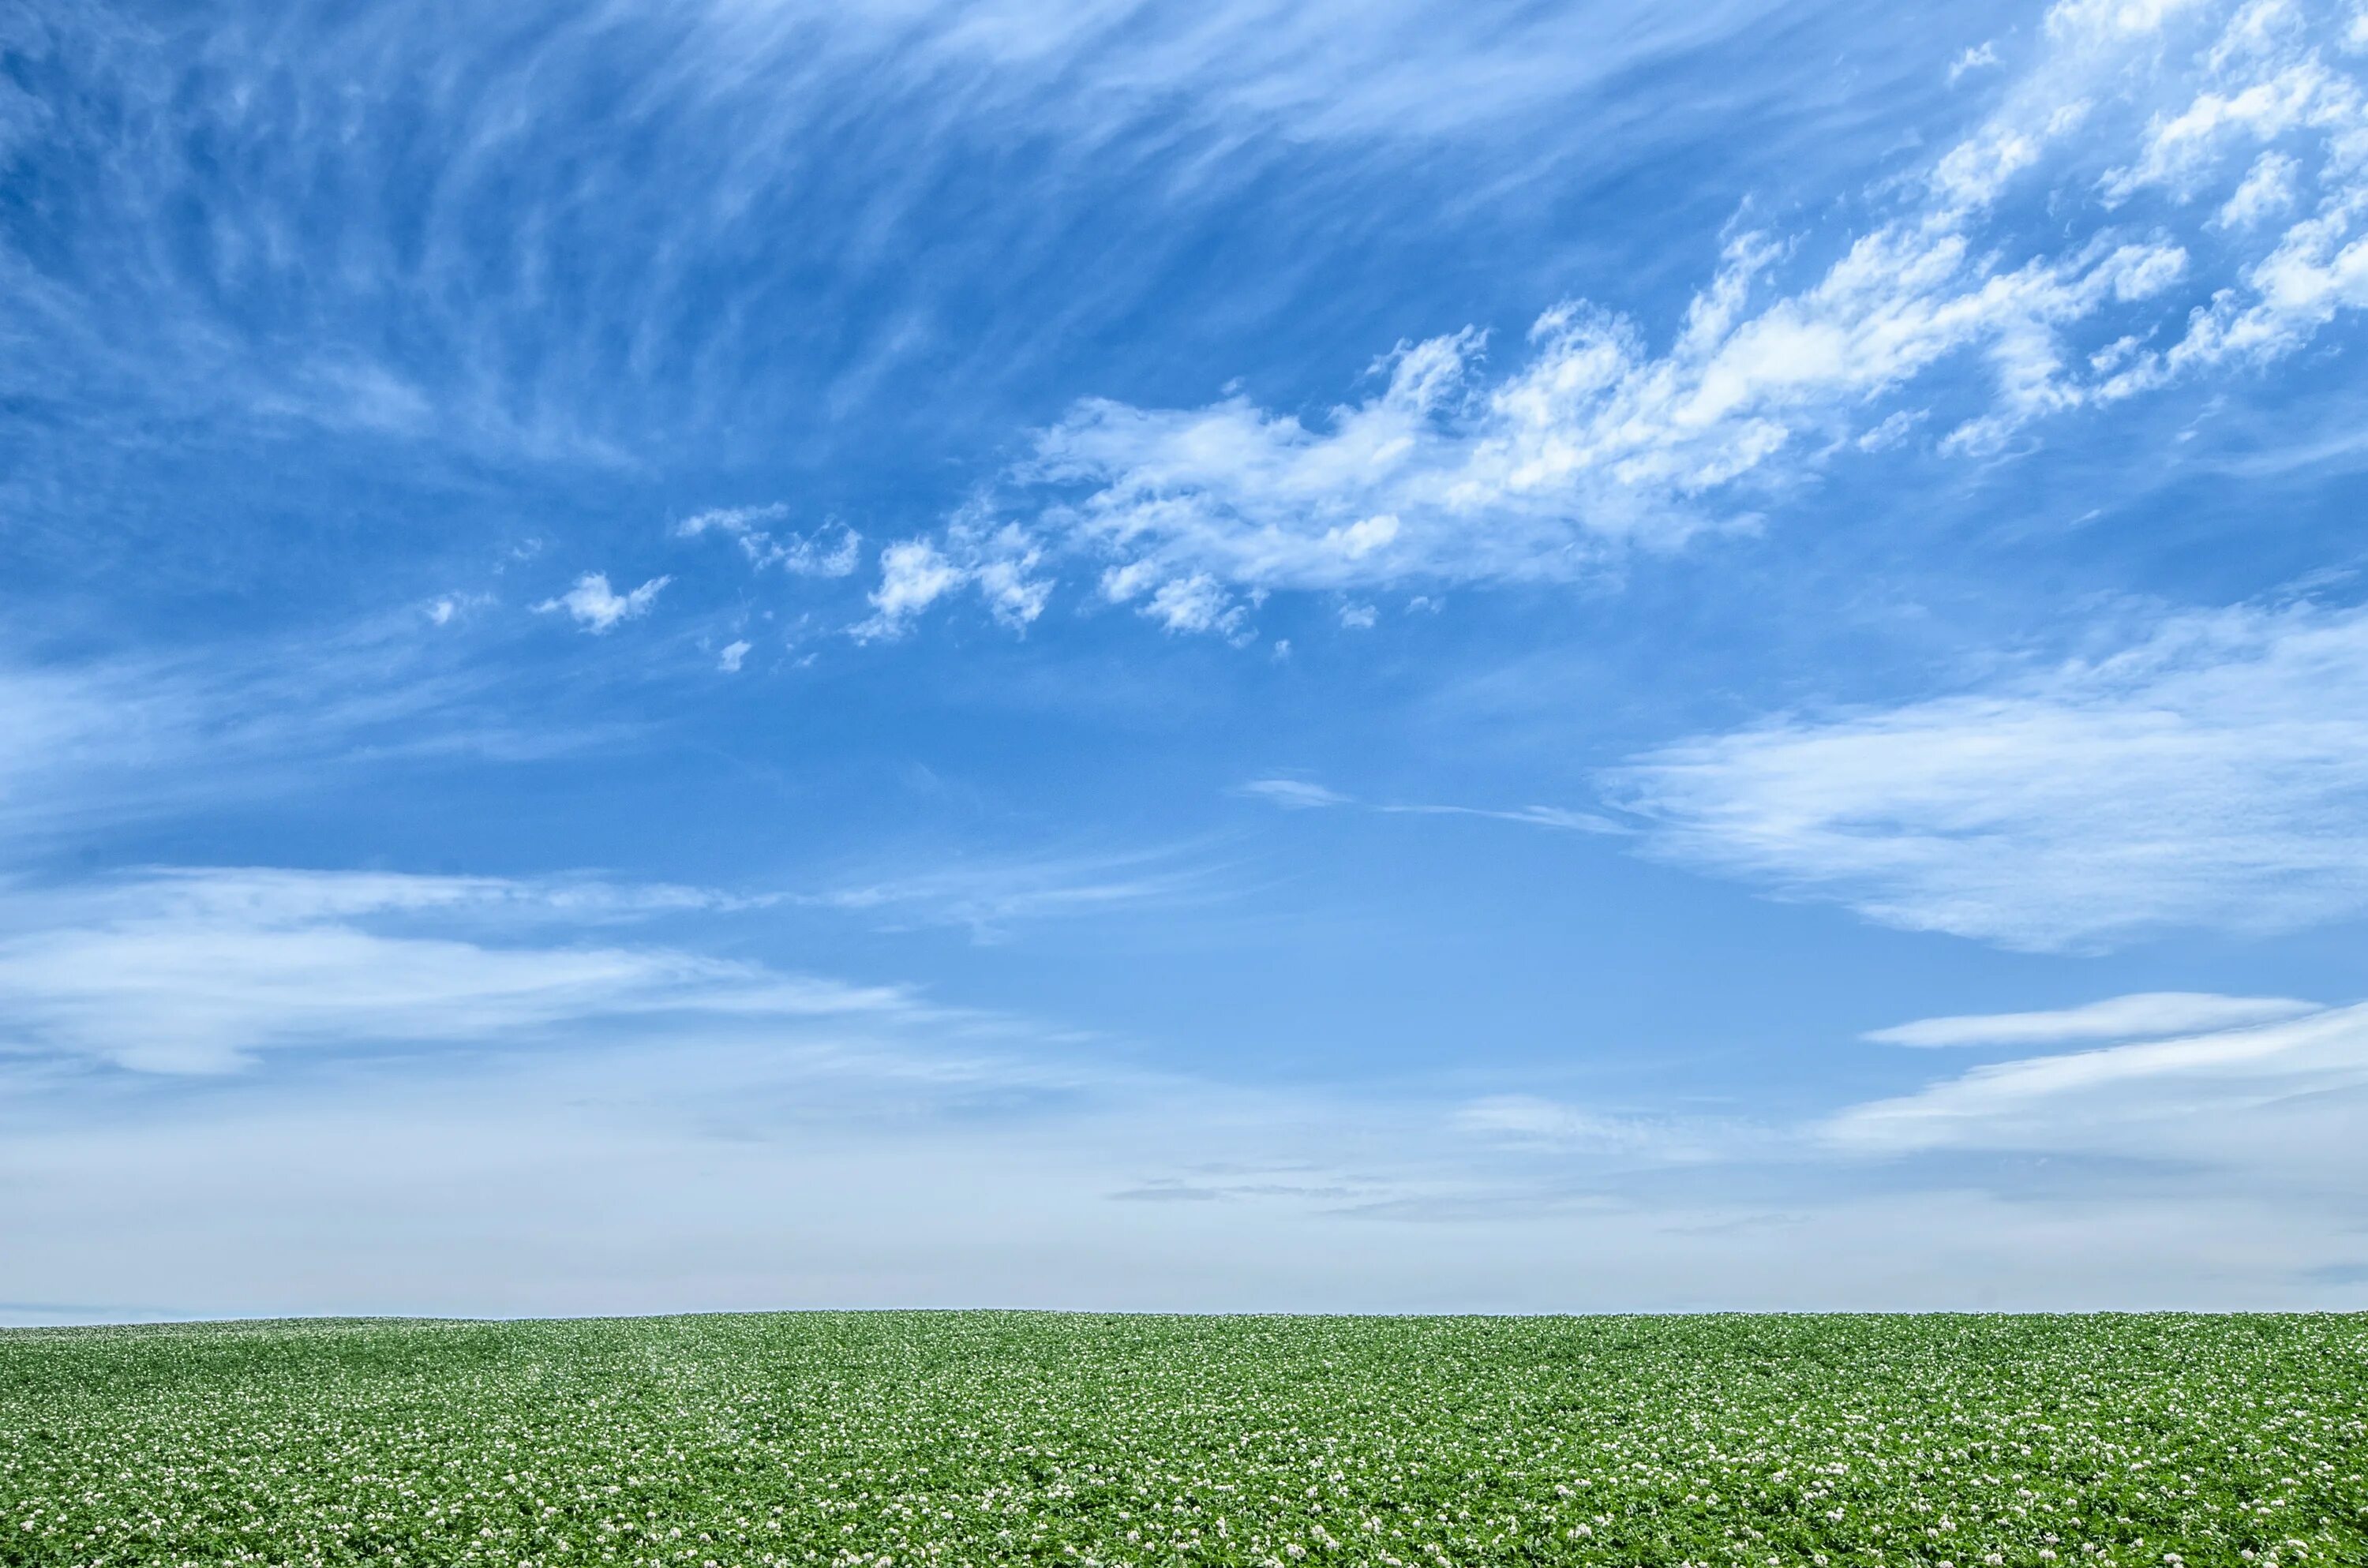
[848,0,2368,637]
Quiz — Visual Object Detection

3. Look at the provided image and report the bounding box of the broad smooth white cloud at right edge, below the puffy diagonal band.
[1606,606,2368,950]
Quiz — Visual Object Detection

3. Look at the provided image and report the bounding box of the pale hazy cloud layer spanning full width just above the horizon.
[0,870,2368,1319]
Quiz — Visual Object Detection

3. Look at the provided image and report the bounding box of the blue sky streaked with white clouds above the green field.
[0,0,2368,1324]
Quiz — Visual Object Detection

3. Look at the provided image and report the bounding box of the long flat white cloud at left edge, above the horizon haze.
[0,870,919,1073]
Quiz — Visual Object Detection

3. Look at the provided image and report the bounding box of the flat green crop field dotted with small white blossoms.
[0,1312,2368,1568]
